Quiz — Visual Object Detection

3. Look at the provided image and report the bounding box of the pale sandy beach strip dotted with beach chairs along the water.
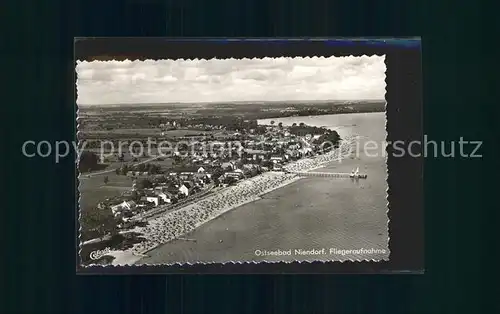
[107,136,356,266]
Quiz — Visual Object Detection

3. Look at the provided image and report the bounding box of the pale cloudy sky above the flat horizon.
[76,56,386,105]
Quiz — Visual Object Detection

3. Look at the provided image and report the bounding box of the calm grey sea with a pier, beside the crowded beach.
[138,112,390,264]
